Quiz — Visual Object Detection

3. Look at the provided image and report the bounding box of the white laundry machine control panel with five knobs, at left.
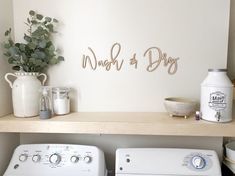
[3,144,107,176]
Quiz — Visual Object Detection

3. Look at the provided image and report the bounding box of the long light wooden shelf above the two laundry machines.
[0,112,235,137]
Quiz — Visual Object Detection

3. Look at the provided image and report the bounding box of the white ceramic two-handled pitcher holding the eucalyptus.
[5,72,47,117]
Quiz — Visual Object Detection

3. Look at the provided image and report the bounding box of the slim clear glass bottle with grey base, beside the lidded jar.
[39,86,52,119]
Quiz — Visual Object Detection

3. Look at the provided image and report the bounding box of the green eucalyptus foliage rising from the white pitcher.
[4,10,64,72]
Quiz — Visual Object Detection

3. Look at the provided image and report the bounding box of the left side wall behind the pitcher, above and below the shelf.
[0,0,20,175]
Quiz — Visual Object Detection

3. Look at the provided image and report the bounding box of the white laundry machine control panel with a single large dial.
[115,148,222,176]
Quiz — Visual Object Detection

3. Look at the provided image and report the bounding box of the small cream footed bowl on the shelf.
[164,97,197,118]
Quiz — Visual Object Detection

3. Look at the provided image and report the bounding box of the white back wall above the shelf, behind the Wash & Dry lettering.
[13,0,230,111]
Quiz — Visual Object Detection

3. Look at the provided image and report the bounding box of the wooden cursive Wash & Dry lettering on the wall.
[82,43,179,75]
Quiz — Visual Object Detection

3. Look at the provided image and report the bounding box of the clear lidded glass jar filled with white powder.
[52,87,70,115]
